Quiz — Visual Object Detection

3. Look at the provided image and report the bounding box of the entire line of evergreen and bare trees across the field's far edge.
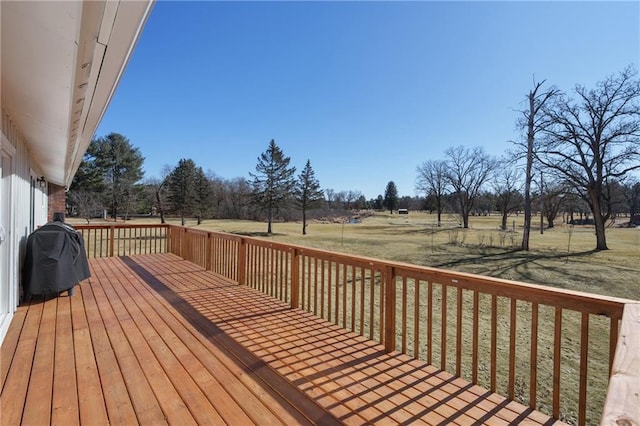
[69,67,640,250]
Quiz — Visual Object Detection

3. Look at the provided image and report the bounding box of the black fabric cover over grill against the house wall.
[23,222,91,300]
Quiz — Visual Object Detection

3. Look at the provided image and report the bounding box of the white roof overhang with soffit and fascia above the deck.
[0,0,154,187]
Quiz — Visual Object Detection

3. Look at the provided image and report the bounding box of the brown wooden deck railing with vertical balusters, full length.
[78,225,640,425]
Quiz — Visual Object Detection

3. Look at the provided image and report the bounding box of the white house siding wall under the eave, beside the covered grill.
[0,108,47,342]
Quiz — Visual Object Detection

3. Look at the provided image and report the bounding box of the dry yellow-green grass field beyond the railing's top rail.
[121,212,640,300]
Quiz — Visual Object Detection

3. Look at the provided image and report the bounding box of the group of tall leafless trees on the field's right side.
[417,67,640,250]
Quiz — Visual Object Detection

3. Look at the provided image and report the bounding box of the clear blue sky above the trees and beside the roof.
[96,1,640,198]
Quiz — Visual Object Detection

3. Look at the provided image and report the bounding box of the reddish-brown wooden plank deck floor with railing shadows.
[0,254,553,425]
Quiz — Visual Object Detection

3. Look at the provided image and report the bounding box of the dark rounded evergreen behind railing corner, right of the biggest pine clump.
[167,158,197,226]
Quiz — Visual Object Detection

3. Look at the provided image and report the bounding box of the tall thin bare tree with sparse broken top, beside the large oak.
[518,79,560,250]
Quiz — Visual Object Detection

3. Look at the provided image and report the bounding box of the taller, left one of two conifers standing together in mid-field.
[249,139,296,234]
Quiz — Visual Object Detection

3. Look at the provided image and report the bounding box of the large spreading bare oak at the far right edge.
[536,67,640,250]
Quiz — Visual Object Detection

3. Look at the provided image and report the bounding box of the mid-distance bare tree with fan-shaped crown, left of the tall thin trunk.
[445,146,496,229]
